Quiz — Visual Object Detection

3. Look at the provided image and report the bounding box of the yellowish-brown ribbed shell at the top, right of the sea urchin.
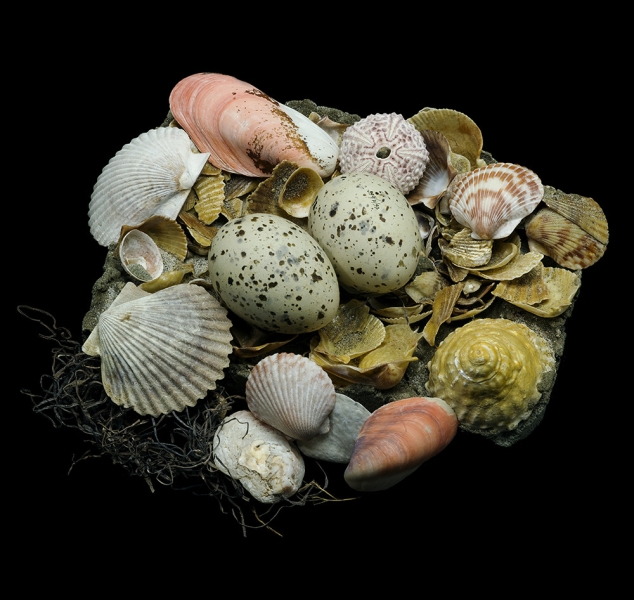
[408,107,484,170]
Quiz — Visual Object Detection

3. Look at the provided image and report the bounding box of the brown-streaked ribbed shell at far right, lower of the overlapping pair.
[526,208,606,269]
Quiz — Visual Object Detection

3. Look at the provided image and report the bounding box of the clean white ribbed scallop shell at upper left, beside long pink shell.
[88,127,209,246]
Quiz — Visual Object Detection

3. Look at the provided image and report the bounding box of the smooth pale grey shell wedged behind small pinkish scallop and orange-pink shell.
[297,394,370,464]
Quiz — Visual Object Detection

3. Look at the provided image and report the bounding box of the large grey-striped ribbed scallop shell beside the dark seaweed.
[82,283,231,417]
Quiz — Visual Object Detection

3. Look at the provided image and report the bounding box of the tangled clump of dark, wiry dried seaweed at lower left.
[18,306,336,535]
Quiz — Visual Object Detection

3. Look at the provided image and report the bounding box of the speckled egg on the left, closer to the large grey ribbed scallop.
[209,214,339,333]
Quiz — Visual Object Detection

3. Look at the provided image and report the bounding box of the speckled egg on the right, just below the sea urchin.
[308,173,423,294]
